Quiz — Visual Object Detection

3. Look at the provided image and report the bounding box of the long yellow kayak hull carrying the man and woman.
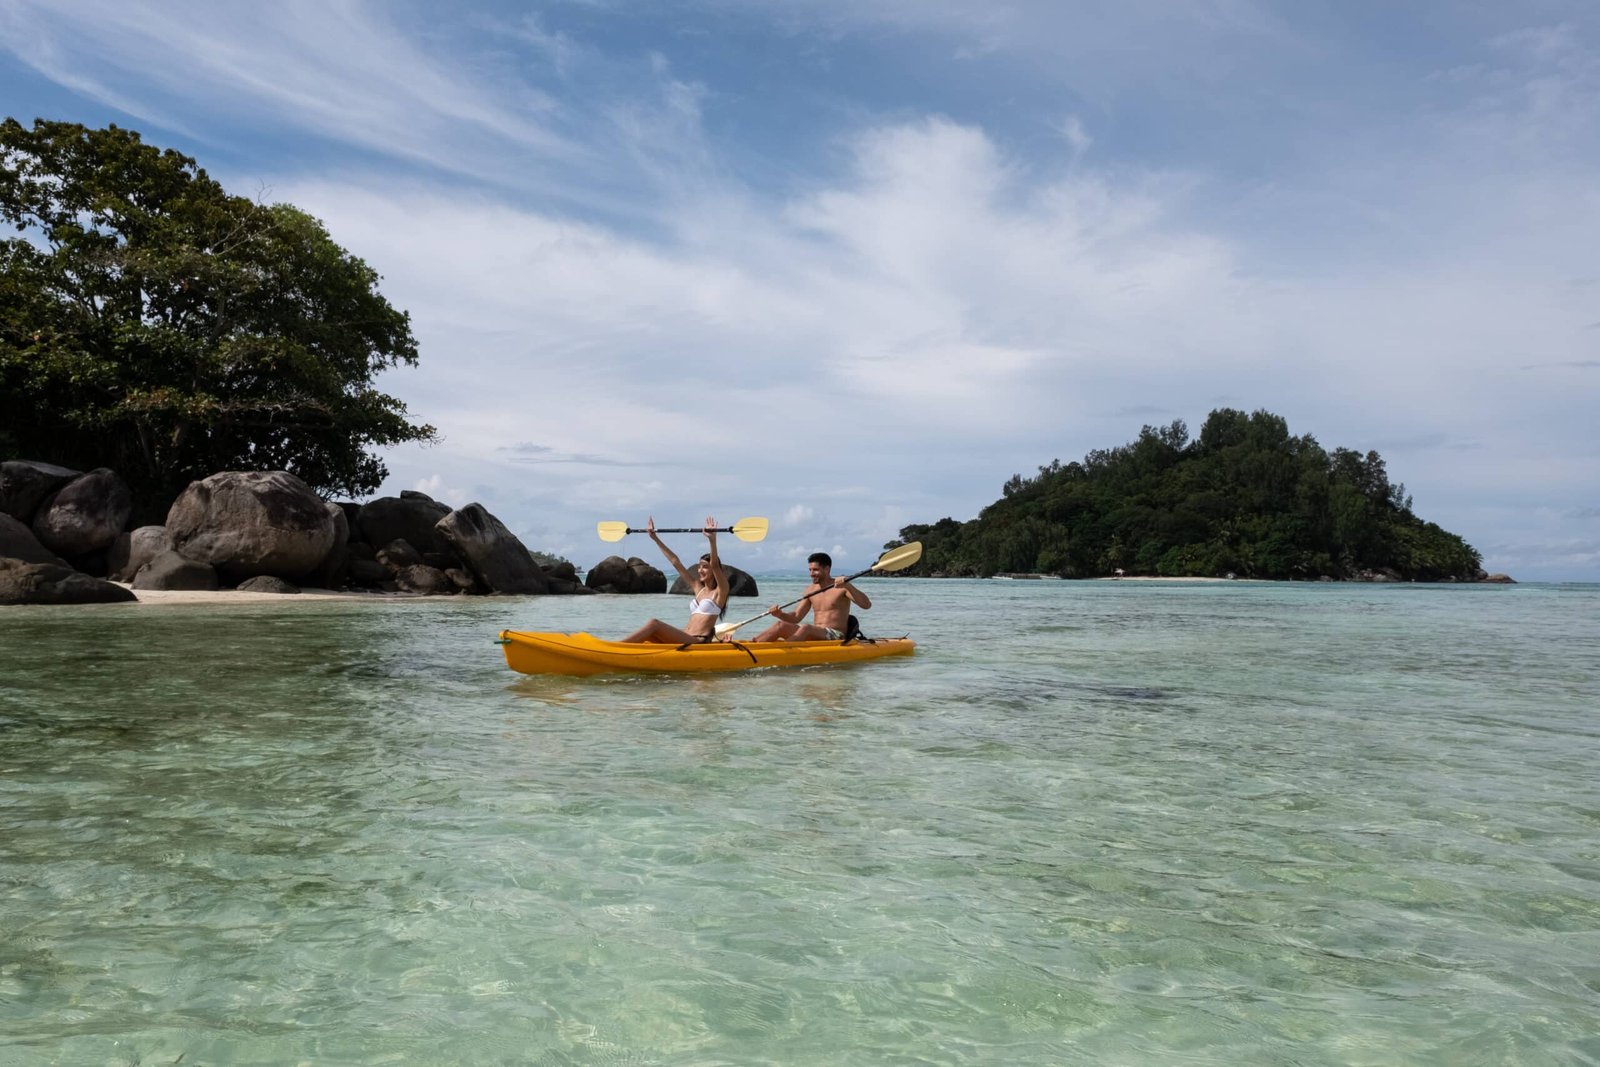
[498,630,917,675]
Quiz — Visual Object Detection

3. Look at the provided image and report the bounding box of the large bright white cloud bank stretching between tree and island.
[268,99,1600,575]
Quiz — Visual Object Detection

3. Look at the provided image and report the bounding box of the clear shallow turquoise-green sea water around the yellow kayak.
[0,579,1600,1067]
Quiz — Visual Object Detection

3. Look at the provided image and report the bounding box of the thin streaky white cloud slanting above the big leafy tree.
[0,0,672,214]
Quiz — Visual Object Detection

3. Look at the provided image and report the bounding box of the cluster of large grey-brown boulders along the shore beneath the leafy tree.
[0,459,588,601]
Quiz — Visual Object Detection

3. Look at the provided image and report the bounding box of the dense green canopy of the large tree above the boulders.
[0,118,434,507]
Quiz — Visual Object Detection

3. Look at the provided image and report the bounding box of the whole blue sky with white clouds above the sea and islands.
[0,0,1600,581]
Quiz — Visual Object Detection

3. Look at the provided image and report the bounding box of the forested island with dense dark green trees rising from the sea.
[885,408,1485,581]
